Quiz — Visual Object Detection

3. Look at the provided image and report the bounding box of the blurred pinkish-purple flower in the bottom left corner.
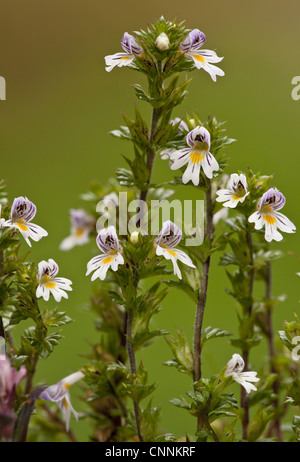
[0,355,26,439]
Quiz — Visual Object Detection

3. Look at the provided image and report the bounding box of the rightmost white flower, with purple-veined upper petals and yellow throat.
[249,188,296,242]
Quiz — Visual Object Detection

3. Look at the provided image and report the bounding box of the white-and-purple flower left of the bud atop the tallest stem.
[105,32,143,72]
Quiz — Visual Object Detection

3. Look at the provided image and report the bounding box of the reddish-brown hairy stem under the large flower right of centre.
[193,182,214,428]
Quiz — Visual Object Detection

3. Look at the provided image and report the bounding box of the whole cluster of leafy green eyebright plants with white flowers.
[0,17,300,442]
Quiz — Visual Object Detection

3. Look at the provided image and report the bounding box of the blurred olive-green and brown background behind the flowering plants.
[0,0,300,441]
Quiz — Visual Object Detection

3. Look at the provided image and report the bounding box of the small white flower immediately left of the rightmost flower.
[216,173,250,209]
